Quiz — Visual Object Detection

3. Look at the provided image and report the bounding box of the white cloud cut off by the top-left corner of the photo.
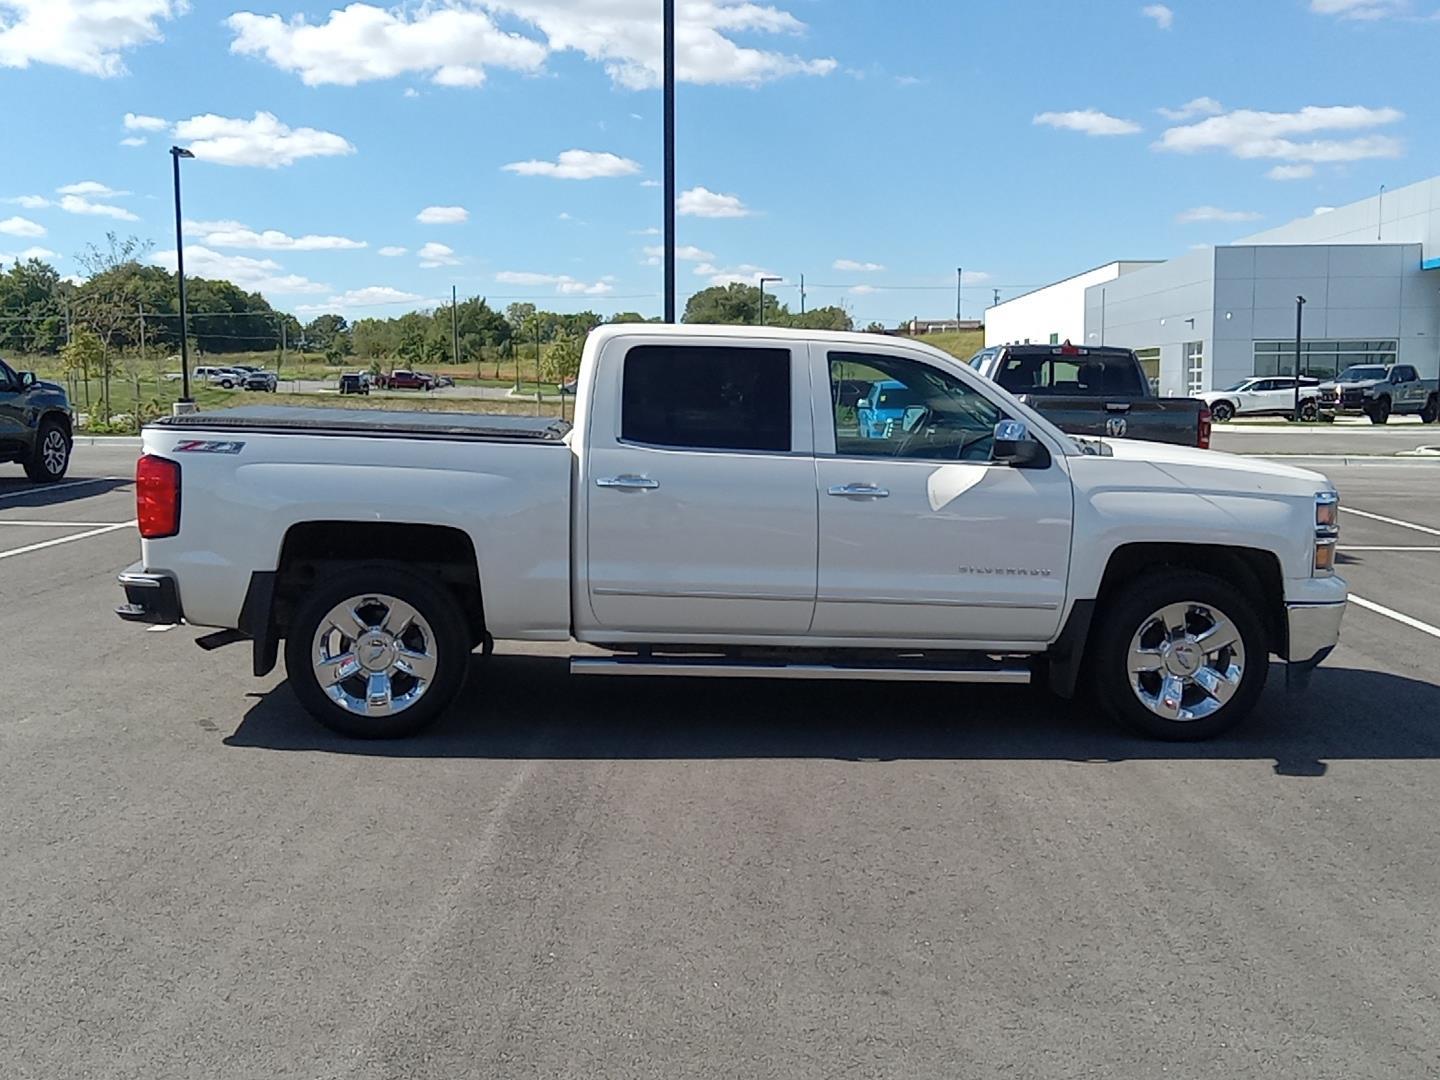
[0,0,189,78]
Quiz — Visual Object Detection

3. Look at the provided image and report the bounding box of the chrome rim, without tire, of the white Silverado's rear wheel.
[311,593,436,716]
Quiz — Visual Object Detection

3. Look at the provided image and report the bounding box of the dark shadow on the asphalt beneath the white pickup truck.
[225,657,1440,776]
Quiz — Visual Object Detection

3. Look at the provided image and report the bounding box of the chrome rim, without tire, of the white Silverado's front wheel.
[1129,602,1246,721]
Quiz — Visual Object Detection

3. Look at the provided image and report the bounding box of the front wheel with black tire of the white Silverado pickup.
[1087,570,1270,742]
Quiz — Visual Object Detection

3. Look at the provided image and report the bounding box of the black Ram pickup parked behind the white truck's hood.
[966,341,1210,449]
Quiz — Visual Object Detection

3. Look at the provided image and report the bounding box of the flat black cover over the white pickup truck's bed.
[153,405,570,442]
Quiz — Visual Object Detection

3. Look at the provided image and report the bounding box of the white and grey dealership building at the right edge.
[985,177,1440,395]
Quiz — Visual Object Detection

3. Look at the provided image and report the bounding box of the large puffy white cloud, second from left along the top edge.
[225,3,547,86]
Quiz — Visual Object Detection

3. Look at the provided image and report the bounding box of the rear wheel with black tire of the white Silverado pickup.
[285,563,471,739]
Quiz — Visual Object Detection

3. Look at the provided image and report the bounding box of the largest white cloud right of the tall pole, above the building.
[1155,105,1404,163]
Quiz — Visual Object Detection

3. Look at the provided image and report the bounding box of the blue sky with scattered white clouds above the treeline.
[0,0,1440,324]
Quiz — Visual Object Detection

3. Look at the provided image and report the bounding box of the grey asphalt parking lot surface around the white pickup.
[0,433,1440,1080]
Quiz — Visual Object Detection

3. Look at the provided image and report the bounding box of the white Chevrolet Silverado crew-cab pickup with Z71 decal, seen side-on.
[118,324,1346,739]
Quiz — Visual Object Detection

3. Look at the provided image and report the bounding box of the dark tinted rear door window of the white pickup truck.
[621,346,791,454]
